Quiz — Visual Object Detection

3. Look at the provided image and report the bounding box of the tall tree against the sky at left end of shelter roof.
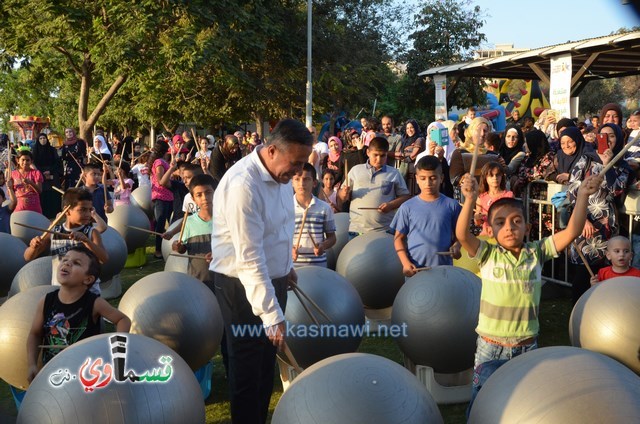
[395,0,485,121]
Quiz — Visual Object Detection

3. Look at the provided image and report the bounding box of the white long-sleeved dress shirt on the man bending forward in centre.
[209,146,295,326]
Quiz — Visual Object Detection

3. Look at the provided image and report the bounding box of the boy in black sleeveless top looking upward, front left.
[27,246,131,382]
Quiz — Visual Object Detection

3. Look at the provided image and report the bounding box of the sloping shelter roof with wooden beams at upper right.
[418,31,640,88]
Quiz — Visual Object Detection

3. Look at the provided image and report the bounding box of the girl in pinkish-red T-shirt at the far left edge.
[11,150,44,214]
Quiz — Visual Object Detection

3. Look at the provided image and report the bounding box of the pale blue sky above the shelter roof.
[472,0,640,49]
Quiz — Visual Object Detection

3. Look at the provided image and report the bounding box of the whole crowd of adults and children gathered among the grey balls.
[5,104,640,422]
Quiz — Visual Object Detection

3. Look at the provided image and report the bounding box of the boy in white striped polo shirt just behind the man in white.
[291,163,336,267]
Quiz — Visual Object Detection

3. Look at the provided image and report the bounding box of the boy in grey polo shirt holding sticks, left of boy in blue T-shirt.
[338,137,411,237]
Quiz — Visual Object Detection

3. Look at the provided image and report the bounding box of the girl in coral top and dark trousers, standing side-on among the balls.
[147,141,176,259]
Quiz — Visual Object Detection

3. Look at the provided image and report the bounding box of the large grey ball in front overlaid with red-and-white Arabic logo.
[17,333,205,424]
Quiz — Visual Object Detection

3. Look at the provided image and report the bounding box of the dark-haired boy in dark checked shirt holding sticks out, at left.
[24,188,109,295]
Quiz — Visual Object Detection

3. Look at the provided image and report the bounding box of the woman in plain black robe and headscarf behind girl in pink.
[33,133,62,219]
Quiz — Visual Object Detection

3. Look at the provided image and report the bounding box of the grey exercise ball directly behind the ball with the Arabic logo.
[118,272,223,370]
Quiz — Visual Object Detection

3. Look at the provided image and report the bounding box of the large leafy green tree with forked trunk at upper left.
[0,0,241,139]
